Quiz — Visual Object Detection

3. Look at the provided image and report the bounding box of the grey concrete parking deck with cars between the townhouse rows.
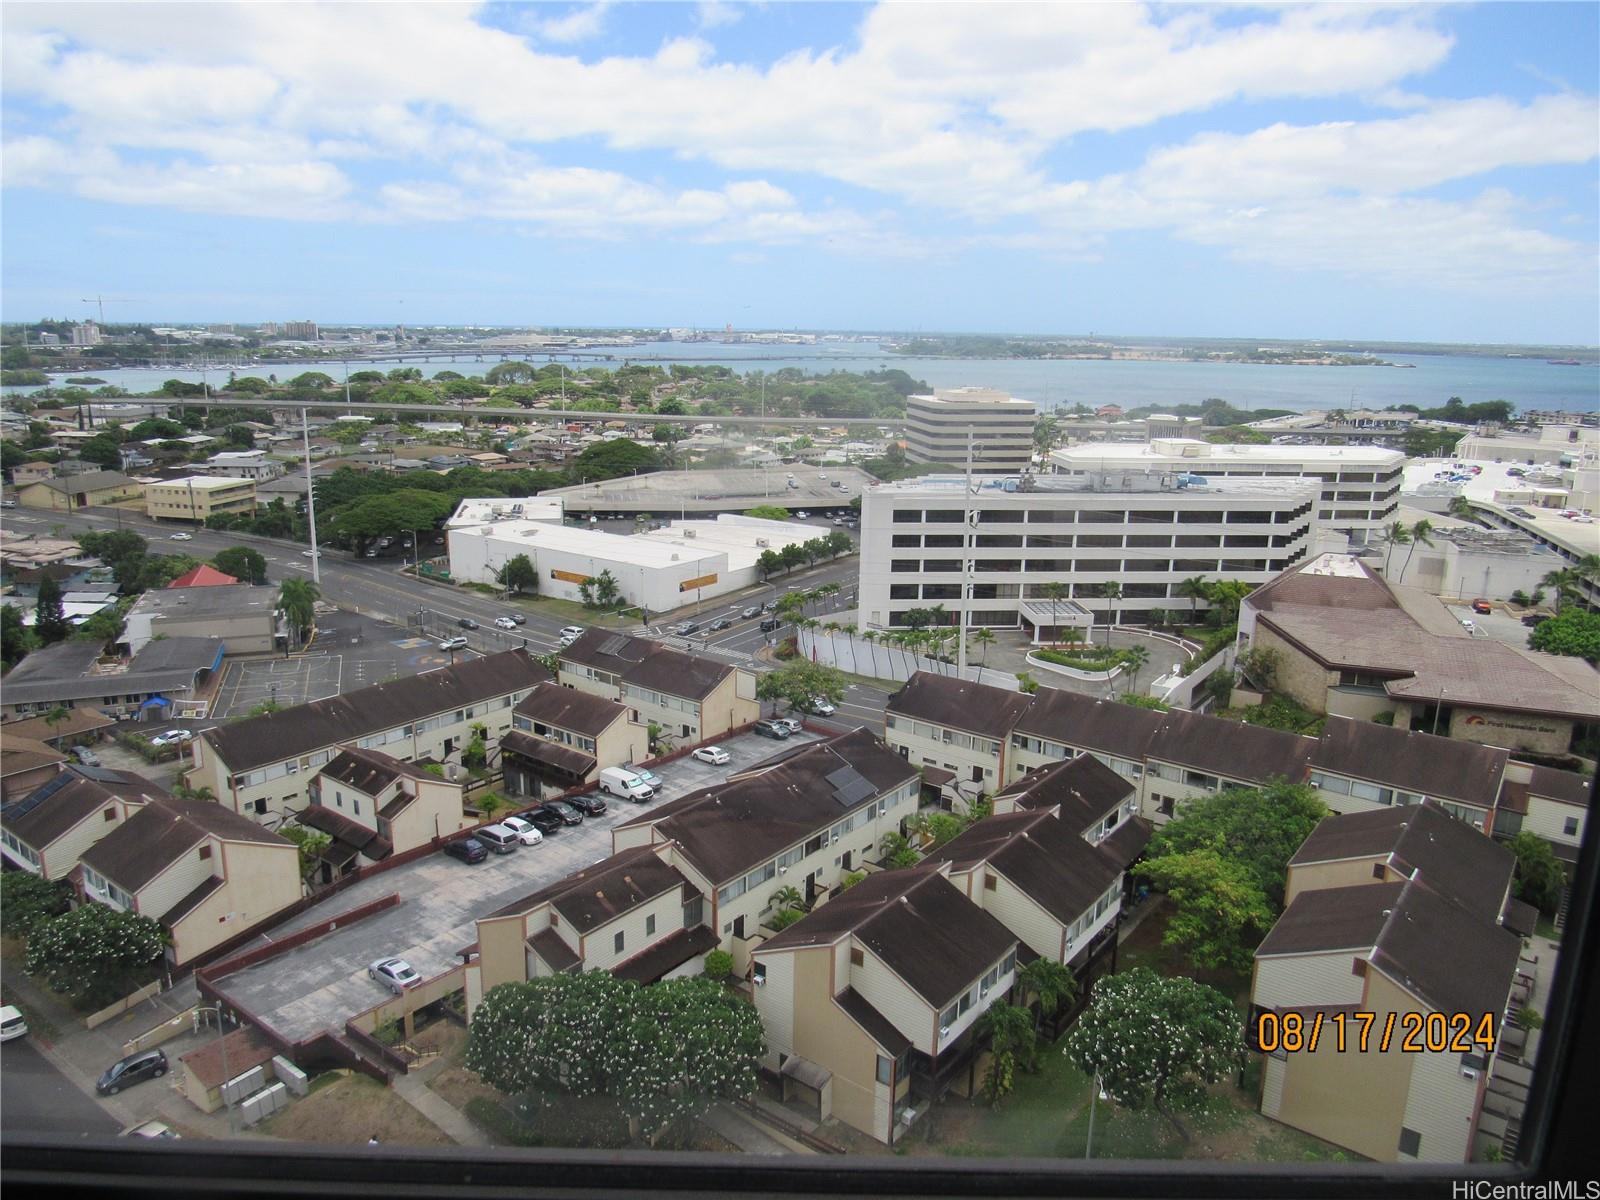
[219,731,821,1038]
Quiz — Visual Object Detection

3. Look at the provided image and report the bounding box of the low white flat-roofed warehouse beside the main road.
[450,514,822,613]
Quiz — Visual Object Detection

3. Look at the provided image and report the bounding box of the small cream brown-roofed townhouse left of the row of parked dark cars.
[294,746,475,883]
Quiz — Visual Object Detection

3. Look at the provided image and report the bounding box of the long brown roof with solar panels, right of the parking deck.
[624,730,917,883]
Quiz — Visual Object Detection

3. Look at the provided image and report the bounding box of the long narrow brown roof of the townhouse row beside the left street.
[200,650,550,771]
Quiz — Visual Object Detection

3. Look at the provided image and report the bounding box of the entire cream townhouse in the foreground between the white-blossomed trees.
[752,866,1019,1144]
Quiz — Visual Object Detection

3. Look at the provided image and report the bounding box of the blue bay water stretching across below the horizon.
[5,342,1600,411]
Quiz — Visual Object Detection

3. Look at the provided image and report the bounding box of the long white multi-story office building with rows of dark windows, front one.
[859,469,1318,629]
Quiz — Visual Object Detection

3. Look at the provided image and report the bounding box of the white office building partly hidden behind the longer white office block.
[1050,437,1405,554]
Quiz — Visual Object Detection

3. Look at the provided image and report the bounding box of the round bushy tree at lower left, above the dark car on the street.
[27,901,166,1006]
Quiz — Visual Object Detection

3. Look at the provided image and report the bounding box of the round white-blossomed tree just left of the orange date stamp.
[1066,966,1245,1142]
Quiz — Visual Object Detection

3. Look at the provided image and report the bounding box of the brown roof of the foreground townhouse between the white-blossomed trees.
[757,867,1018,1010]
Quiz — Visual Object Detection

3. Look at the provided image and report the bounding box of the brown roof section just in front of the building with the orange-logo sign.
[1310,717,1509,808]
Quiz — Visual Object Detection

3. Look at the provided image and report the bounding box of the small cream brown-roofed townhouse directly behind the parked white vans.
[499,683,650,798]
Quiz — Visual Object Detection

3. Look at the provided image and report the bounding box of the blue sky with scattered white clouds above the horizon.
[0,3,1600,344]
